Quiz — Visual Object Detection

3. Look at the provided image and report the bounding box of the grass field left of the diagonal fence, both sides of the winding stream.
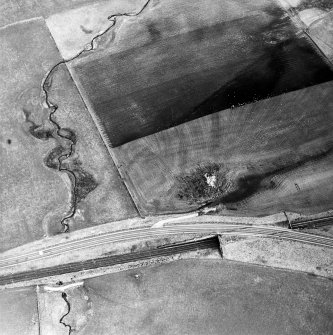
[0,18,137,251]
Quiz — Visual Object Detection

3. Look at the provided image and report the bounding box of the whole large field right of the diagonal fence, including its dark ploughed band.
[70,0,333,215]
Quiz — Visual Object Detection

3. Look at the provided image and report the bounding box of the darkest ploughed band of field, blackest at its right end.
[74,2,333,147]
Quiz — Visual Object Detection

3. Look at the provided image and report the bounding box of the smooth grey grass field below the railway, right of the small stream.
[80,260,333,335]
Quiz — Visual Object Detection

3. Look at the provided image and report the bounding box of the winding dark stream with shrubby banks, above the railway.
[40,0,151,232]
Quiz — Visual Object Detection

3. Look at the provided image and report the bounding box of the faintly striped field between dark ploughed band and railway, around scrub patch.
[113,82,333,215]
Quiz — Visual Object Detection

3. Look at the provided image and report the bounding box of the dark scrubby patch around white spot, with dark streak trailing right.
[176,144,333,206]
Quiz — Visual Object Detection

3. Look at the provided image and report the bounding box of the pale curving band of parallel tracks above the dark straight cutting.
[0,220,333,270]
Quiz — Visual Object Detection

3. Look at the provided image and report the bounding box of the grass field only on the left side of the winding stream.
[0,19,70,251]
